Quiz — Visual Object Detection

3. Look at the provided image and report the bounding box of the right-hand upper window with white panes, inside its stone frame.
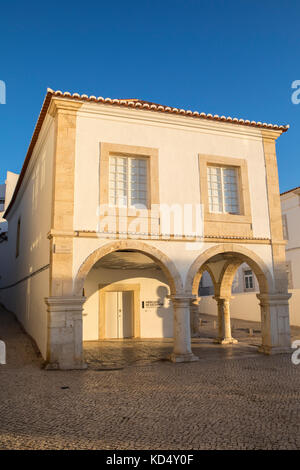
[207,165,239,214]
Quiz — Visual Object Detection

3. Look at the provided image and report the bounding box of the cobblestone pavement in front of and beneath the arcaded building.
[0,309,300,450]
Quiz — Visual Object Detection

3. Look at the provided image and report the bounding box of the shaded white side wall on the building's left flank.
[0,117,54,357]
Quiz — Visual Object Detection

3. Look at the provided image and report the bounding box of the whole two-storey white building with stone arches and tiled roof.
[0,90,290,368]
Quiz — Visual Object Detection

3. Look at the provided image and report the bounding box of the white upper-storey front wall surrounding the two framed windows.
[74,103,270,241]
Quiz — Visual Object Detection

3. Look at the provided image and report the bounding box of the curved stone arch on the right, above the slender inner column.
[185,244,273,295]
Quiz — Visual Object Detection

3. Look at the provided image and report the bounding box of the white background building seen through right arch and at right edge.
[199,187,300,326]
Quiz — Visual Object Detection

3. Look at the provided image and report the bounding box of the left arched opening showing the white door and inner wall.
[83,249,173,341]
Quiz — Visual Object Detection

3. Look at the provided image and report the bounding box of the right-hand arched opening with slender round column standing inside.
[185,245,280,348]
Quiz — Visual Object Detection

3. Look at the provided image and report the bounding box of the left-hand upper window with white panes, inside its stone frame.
[109,155,148,208]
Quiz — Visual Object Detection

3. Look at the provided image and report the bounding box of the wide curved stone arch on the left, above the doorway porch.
[73,240,183,296]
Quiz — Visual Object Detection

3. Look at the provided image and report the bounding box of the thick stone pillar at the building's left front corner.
[45,296,87,370]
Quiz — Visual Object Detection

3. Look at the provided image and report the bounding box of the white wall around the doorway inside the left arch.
[83,268,173,340]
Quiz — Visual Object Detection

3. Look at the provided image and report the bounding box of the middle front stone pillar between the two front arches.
[170,296,198,362]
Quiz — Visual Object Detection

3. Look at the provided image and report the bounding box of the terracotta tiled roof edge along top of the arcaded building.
[3,88,289,217]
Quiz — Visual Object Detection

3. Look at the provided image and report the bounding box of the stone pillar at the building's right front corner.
[257,293,292,354]
